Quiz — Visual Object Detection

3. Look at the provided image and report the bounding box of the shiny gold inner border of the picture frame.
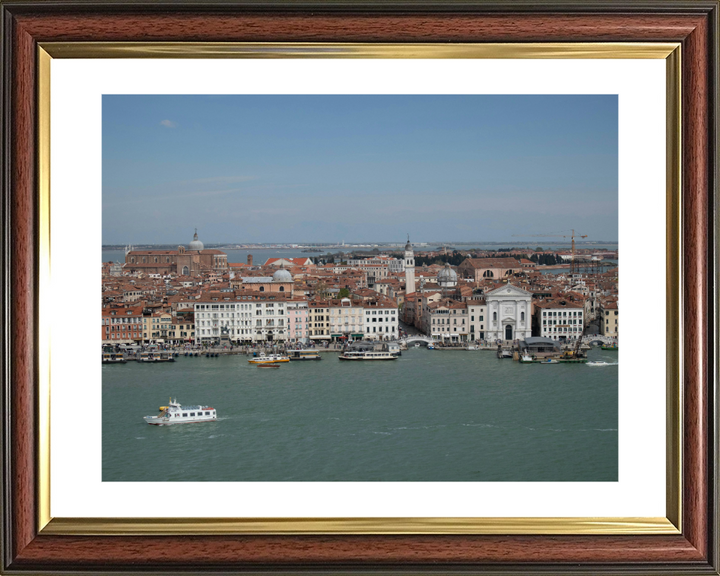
[36,42,683,536]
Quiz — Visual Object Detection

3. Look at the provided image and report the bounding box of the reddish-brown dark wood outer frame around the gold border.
[0,0,719,574]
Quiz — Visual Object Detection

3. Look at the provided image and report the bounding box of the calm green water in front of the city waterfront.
[102,348,618,481]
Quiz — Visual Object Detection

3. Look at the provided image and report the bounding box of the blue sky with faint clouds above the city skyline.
[103,95,618,244]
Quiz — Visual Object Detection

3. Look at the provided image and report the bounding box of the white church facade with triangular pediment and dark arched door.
[485,284,532,341]
